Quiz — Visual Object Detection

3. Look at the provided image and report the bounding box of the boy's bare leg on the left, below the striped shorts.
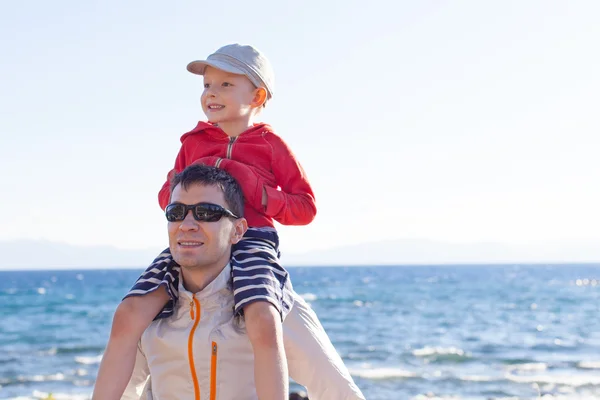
[92,286,170,400]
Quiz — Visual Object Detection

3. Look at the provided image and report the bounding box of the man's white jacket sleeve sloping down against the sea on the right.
[283,293,365,400]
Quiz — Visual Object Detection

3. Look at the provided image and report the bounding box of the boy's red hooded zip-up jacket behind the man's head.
[158,121,317,227]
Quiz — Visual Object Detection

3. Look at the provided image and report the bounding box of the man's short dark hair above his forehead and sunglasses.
[171,164,244,217]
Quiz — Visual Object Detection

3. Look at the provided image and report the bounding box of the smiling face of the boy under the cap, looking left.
[201,67,257,123]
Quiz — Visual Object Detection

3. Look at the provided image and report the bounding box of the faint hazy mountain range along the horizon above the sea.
[0,239,600,269]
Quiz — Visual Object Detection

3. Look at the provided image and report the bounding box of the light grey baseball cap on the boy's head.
[187,43,275,99]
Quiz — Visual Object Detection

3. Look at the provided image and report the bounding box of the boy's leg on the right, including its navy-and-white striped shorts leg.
[231,228,291,400]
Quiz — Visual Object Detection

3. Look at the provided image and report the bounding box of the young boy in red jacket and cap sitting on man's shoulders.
[93,44,316,400]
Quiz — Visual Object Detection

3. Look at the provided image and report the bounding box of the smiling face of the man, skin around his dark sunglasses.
[168,184,244,270]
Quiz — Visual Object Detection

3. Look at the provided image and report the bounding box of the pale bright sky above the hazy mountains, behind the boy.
[0,0,600,252]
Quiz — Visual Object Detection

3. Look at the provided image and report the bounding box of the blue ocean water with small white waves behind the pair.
[0,264,600,400]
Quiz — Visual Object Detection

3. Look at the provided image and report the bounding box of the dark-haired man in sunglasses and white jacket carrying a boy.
[123,165,364,400]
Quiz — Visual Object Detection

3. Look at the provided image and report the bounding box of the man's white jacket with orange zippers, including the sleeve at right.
[122,265,364,400]
